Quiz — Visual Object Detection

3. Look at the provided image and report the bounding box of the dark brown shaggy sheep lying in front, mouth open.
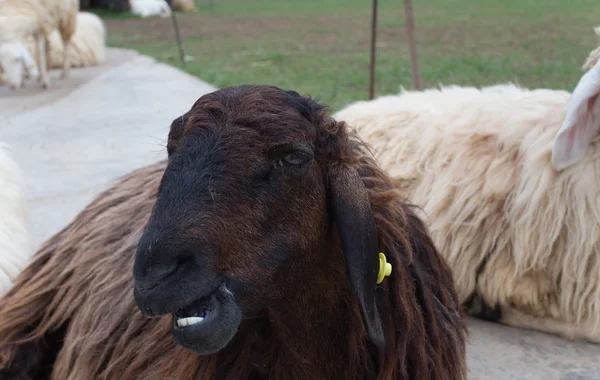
[0,86,466,380]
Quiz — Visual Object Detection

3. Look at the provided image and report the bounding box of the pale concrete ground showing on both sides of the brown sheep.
[0,49,600,380]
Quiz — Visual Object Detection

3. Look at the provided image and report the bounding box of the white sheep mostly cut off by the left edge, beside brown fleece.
[0,142,33,295]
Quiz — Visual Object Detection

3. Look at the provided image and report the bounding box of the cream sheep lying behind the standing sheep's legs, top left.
[27,12,106,68]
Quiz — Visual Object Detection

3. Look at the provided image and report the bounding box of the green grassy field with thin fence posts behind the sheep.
[97,0,600,110]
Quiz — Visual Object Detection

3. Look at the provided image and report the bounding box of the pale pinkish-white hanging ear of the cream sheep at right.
[552,61,600,170]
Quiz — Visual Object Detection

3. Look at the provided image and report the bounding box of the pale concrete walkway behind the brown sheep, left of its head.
[0,49,215,248]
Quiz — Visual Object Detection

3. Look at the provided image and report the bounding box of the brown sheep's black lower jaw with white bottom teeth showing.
[171,285,242,355]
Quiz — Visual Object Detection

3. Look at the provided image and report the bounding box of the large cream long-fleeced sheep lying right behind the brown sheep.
[334,57,600,343]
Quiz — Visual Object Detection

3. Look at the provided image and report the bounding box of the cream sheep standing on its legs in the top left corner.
[0,0,79,88]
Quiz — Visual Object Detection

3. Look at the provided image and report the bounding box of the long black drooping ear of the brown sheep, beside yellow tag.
[329,167,385,353]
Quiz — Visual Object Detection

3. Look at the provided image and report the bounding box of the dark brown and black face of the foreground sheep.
[134,87,336,354]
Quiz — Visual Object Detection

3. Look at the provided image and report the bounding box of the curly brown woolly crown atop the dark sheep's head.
[170,85,319,156]
